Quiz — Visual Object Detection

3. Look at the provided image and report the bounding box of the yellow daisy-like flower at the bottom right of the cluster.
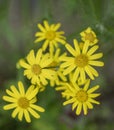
[63,80,100,115]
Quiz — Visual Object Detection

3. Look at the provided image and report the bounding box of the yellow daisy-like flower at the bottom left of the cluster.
[3,81,45,122]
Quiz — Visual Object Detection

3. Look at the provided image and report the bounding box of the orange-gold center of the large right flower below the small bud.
[75,54,88,67]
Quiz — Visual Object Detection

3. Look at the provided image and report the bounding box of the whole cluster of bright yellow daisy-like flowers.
[3,21,104,122]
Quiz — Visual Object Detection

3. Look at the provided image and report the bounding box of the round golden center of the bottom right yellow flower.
[76,90,88,102]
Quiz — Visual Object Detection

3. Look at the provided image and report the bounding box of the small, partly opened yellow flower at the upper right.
[80,27,98,46]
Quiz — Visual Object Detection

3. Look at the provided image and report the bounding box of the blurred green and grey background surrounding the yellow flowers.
[0,0,114,130]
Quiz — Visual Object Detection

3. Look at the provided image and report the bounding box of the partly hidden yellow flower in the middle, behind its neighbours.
[49,48,67,87]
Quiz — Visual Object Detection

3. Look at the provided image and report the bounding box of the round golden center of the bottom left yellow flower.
[18,97,29,109]
